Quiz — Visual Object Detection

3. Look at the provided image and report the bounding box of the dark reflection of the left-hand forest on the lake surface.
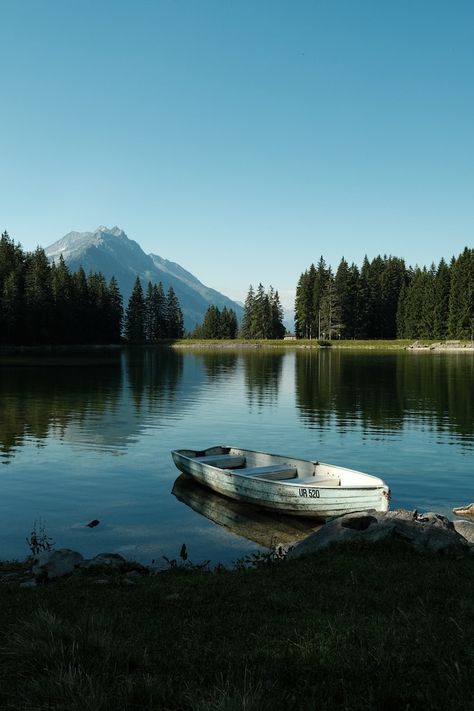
[0,348,187,462]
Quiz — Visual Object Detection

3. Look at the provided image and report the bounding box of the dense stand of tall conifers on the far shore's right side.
[295,247,474,340]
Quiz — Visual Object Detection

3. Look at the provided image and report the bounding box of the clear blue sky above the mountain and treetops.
[0,0,474,303]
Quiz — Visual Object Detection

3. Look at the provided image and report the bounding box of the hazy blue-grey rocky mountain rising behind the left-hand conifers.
[45,226,243,330]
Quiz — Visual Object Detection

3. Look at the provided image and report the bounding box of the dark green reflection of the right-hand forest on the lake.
[295,351,474,439]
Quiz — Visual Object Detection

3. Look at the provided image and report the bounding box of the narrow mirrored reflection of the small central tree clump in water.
[242,349,285,408]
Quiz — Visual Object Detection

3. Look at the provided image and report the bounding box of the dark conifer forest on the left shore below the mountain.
[0,232,183,345]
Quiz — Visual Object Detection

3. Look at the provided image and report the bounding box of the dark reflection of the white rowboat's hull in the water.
[172,474,322,548]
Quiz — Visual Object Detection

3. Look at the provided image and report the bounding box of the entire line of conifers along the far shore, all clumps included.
[0,232,474,345]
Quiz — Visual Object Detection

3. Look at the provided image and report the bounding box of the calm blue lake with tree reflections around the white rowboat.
[0,348,474,565]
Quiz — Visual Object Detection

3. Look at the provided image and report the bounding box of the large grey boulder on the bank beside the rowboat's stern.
[287,509,472,559]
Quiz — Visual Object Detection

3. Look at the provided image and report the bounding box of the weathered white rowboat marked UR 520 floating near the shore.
[171,446,390,519]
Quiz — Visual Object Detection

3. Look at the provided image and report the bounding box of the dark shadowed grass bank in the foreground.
[0,545,474,711]
